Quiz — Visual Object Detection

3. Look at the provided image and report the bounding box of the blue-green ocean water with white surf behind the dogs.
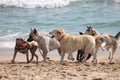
[0,0,120,48]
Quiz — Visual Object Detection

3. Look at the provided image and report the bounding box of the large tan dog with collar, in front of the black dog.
[50,29,97,63]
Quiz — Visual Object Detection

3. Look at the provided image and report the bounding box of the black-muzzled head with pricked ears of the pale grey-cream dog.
[27,29,40,42]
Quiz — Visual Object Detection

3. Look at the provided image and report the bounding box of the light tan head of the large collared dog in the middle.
[49,28,65,40]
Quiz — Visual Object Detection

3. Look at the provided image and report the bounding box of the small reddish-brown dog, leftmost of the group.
[12,38,38,64]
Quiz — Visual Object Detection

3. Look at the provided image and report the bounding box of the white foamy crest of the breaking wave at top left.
[0,0,76,8]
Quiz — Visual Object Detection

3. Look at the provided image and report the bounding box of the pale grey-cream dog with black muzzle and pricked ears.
[27,29,61,62]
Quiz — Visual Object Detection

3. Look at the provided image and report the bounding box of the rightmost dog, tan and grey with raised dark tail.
[85,26,120,63]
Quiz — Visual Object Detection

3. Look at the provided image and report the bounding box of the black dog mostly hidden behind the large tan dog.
[76,32,91,62]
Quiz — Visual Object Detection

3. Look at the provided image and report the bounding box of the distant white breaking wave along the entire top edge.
[0,0,120,8]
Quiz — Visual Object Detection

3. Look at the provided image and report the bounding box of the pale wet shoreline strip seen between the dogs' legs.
[0,46,120,61]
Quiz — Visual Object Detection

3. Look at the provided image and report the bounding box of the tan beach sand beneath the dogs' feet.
[0,47,120,80]
